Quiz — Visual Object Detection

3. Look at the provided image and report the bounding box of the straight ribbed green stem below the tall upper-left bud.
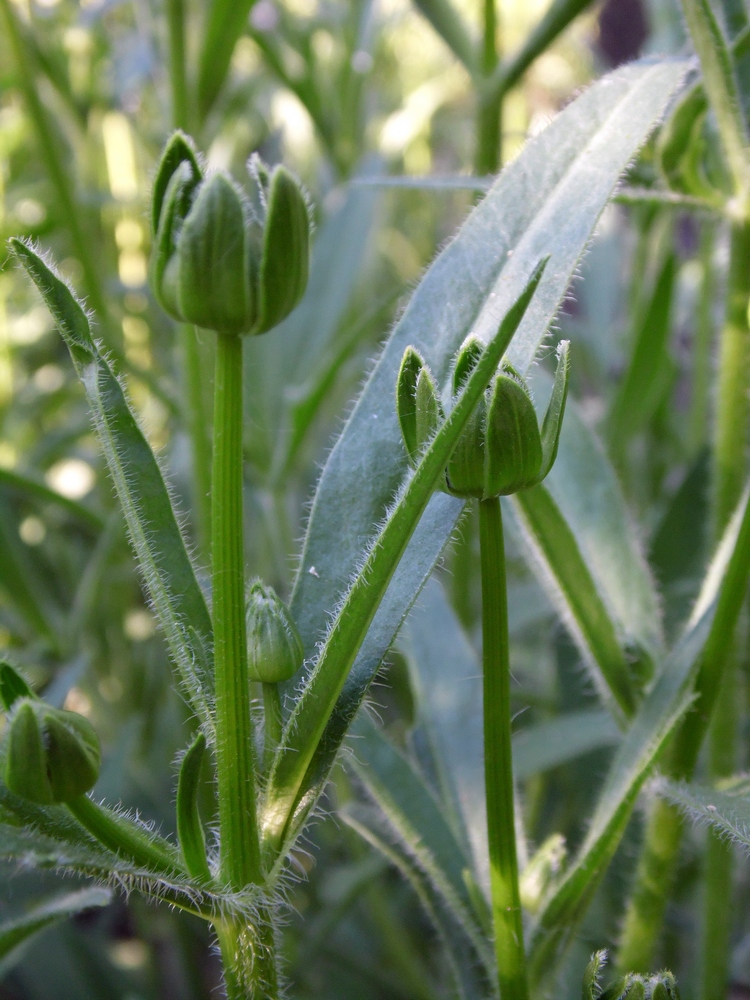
[211,334,261,889]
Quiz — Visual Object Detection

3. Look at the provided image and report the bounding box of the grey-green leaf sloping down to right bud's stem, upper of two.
[349,716,493,977]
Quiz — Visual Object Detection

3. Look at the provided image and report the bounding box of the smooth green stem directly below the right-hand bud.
[479,497,528,1000]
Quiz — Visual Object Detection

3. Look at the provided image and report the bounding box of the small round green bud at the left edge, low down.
[5,698,101,805]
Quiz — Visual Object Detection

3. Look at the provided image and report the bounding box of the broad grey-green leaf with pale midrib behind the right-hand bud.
[274,61,686,864]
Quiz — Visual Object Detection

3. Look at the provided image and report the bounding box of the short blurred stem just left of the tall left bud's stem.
[180,325,211,555]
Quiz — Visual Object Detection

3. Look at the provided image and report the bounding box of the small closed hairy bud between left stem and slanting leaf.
[245,580,305,684]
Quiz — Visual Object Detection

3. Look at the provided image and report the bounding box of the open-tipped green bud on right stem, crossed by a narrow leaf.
[396,337,568,500]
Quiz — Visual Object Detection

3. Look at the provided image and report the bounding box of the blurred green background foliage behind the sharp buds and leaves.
[0,0,750,1000]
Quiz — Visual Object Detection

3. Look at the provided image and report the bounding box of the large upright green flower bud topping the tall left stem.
[151,132,310,334]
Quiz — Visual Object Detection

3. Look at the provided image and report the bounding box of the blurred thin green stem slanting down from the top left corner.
[0,0,107,324]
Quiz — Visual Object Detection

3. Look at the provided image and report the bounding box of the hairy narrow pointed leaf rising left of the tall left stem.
[11,240,213,728]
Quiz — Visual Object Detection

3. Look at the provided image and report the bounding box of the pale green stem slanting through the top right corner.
[682,0,749,200]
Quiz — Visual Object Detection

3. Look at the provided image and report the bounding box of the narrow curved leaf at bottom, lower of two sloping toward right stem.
[340,803,496,1000]
